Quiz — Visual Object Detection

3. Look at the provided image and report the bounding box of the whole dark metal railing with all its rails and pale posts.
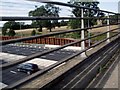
[0,1,120,88]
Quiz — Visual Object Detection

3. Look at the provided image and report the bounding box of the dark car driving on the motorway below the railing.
[17,63,39,75]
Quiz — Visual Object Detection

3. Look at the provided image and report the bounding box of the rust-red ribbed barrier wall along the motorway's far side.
[0,36,91,47]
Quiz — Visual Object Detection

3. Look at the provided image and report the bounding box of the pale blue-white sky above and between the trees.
[0,0,120,27]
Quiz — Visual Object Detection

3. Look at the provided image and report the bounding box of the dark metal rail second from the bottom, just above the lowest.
[0,28,120,69]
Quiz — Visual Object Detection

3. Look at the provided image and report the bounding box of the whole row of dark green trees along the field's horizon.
[2,0,115,36]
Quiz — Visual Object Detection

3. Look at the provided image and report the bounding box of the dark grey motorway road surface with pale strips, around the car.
[0,44,80,88]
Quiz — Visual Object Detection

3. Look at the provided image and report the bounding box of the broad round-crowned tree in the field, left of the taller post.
[29,4,60,31]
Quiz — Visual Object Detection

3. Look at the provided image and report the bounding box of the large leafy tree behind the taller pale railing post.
[68,0,104,28]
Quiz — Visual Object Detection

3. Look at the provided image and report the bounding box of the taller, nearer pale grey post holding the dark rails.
[81,8,86,57]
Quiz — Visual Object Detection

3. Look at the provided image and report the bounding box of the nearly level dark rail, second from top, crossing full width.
[0,16,120,21]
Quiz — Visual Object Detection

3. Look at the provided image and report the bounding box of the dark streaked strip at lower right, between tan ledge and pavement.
[40,37,120,90]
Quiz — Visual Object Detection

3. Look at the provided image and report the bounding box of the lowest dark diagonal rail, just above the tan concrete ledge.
[3,32,120,89]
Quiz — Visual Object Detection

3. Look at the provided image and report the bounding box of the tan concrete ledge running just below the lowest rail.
[18,36,119,88]
